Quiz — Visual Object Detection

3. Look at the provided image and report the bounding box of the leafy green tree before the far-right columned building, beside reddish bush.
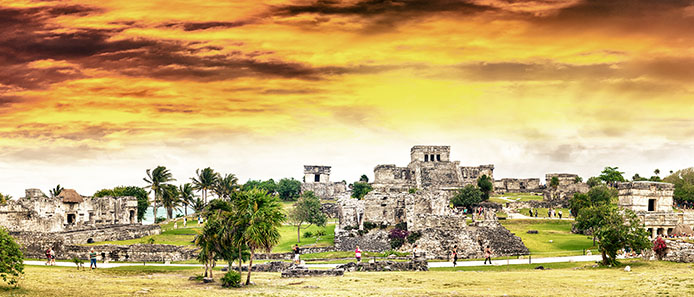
[592,205,651,265]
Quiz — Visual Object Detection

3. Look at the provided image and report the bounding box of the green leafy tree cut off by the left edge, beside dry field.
[0,227,24,286]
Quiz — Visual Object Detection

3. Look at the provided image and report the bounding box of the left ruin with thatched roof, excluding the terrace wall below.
[0,189,138,232]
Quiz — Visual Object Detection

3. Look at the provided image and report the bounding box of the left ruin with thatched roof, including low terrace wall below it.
[0,189,161,257]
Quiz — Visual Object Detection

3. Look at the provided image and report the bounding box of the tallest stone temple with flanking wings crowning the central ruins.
[373,145,494,192]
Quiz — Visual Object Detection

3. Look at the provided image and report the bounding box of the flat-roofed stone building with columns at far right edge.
[617,181,694,237]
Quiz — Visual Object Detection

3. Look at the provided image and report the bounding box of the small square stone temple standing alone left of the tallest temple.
[301,165,347,200]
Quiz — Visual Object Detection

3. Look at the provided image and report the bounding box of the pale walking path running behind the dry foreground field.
[24,255,601,268]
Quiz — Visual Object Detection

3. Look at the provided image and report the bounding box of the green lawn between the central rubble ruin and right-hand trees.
[500,220,595,257]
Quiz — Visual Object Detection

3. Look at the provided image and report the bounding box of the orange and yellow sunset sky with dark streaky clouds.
[0,0,694,198]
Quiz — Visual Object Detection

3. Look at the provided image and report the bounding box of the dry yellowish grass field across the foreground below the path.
[8,261,694,297]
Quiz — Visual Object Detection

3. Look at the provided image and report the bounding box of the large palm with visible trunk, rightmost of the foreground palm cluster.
[235,189,286,285]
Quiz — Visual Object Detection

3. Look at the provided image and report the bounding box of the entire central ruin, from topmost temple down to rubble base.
[335,146,528,258]
